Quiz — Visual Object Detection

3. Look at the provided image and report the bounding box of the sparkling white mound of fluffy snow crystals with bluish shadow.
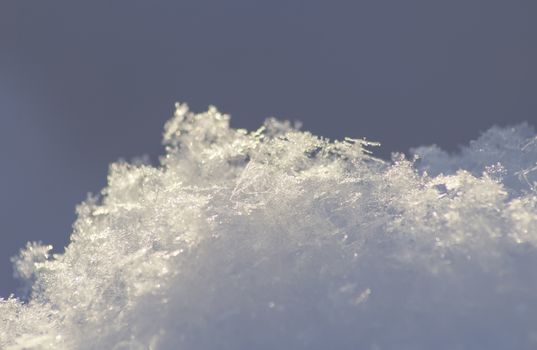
[0,104,537,350]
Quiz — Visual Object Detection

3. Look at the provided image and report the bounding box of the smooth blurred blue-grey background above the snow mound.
[0,0,537,296]
